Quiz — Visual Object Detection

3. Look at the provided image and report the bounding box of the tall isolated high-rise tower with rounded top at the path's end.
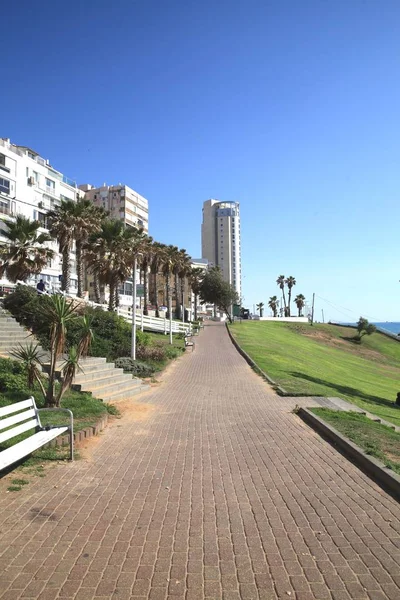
[201,199,242,298]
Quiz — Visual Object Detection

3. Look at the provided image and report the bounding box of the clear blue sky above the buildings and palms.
[0,0,400,321]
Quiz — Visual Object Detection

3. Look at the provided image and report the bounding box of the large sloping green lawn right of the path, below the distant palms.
[230,321,400,425]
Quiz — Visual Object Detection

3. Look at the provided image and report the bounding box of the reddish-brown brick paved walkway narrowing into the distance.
[0,325,400,600]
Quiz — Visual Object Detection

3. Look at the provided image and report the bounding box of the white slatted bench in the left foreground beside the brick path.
[0,397,74,471]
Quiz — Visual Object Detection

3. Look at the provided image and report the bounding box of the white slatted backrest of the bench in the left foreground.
[0,397,40,443]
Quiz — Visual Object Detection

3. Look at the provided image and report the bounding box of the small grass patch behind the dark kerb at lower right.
[310,408,400,475]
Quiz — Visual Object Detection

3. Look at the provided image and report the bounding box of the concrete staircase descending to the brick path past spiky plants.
[0,308,150,402]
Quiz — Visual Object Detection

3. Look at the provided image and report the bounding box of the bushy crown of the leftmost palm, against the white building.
[0,215,54,283]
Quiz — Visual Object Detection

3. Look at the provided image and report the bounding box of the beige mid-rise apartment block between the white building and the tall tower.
[79,183,149,233]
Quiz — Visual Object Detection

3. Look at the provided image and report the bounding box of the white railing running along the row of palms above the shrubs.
[7,281,192,335]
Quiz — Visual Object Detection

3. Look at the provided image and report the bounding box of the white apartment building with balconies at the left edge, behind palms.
[0,138,83,293]
